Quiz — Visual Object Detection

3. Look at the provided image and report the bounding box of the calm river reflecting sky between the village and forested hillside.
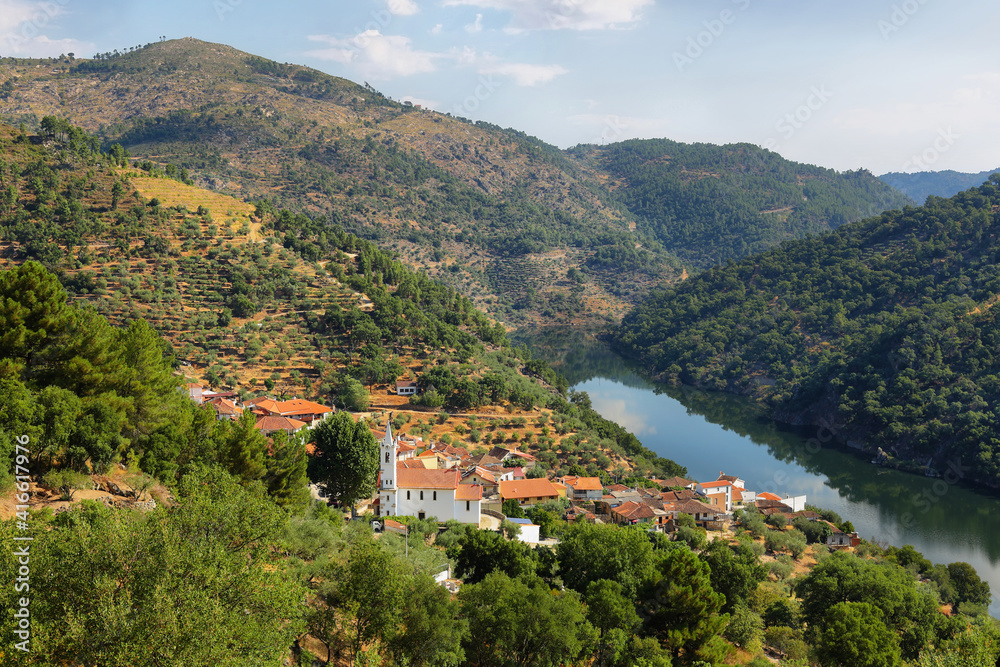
[529,332,1000,618]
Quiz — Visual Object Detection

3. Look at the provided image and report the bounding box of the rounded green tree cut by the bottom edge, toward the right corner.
[816,602,903,667]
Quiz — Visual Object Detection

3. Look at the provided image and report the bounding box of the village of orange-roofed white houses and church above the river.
[186,382,861,548]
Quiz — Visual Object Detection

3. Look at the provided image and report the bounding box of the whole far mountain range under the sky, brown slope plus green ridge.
[0,39,903,328]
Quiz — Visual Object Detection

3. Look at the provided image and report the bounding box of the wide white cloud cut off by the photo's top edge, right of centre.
[442,0,655,32]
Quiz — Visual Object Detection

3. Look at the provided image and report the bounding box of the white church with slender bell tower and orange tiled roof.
[378,422,483,526]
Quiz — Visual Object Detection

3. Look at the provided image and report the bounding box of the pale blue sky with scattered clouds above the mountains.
[0,0,1000,174]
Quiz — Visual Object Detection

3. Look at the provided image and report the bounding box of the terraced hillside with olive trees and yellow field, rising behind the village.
[0,117,683,482]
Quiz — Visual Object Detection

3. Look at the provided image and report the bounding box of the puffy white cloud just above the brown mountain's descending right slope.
[306,30,443,79]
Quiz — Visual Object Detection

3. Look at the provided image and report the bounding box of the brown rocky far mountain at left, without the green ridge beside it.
[0,39,679,324]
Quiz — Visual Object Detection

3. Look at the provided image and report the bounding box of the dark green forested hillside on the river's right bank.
[613,176,1000,486]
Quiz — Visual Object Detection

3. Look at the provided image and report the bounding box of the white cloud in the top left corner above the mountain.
[0,0,94,58]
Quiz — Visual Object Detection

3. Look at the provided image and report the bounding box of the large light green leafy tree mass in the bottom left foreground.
[6,471,303,667]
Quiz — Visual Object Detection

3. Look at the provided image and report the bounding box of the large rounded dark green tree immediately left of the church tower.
[309,412,379,508]
